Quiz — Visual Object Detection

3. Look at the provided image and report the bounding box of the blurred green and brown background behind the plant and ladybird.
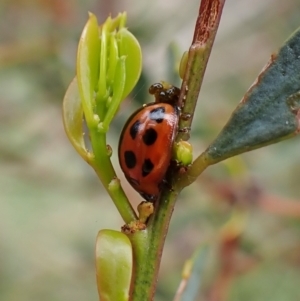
[0,0,300,301]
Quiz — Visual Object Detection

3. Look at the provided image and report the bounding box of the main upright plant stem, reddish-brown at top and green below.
[129,0,225,301]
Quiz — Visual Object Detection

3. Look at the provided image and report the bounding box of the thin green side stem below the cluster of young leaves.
[89,129,137,223]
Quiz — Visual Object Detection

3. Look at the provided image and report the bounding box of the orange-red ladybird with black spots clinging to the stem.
[118,83,180,202]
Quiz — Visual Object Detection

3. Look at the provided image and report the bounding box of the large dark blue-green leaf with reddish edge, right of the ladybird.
[205,30,300,163]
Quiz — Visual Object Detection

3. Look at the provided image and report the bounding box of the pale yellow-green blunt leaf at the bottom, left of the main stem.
[96,230,133,301]
